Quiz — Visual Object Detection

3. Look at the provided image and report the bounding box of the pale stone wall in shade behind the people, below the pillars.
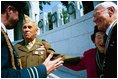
[38,12,94,56]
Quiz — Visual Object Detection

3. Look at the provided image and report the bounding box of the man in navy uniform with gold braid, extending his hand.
[1,1,63,78]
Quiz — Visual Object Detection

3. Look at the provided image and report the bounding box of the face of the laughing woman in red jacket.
[95,32,105,53]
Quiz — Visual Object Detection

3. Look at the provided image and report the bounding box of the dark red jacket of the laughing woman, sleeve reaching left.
[64,49,97,78]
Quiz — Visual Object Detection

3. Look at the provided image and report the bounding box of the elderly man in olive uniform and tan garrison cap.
[14,15,80,68]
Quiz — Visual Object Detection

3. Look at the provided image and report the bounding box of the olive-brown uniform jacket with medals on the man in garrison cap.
[14,38,79,68]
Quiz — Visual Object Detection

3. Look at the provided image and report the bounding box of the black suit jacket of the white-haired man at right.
[103,23,117,78]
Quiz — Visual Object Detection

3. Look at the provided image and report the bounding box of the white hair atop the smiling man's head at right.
[95,1,117,11]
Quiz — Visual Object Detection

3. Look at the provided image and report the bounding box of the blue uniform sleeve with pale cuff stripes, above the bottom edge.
[1,65,47,78]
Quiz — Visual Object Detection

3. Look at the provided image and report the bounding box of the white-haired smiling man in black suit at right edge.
[94,2,117,78]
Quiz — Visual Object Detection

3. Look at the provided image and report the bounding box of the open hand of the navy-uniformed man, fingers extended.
[43,53,64,74]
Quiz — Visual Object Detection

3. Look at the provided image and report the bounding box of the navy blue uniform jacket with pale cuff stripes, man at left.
[1,30,47,78]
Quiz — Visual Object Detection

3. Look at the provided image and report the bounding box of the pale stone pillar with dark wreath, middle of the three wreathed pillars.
[52,4,64,29]
